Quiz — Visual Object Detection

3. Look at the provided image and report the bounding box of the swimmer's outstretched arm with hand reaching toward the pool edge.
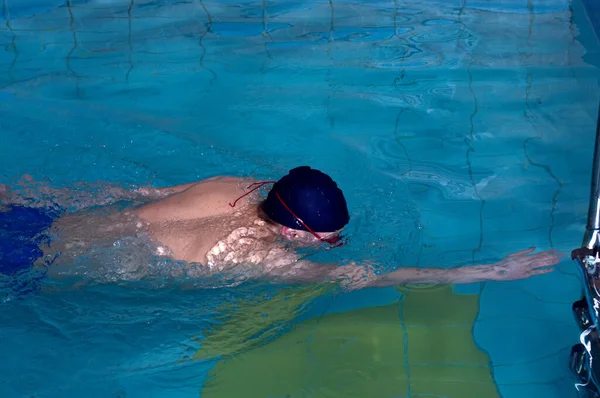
[330,247,562,289]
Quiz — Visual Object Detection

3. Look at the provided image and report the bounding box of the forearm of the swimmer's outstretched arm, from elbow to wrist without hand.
[367,264,499,287]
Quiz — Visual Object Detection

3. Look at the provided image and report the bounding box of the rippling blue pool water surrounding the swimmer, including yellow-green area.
[0,0,600,398]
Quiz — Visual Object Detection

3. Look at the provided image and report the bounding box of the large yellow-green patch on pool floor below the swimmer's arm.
[201,286,499,398]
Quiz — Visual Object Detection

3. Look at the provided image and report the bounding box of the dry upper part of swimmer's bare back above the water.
[135,177,264,264]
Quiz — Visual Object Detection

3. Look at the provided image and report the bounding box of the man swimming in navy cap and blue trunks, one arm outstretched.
[0,166,562,289]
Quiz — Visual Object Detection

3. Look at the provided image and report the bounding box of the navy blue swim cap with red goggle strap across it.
[263,166,350,232]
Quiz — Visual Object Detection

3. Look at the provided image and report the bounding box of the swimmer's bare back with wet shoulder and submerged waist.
[45,177,286,274]
